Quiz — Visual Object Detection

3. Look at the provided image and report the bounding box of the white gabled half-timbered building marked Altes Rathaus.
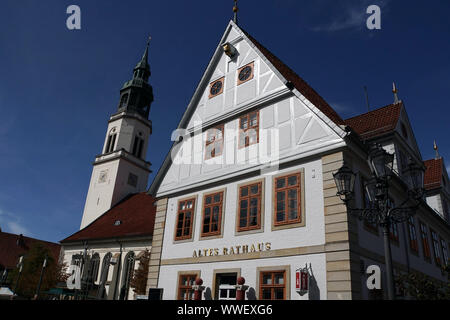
[148,21,450,300]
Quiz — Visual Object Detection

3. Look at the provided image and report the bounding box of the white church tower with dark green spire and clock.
[80,43,153,229]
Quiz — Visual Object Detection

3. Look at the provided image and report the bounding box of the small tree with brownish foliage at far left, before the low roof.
[8,243,68,298]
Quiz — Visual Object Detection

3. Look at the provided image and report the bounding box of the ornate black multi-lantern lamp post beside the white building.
[333,144,423,300]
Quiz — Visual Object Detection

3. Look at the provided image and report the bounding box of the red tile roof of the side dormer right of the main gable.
[345,103,403,139]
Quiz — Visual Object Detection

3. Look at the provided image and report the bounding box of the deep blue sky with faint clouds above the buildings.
[0,0,450,241]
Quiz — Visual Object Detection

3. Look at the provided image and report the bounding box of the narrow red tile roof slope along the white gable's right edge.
[241,28,344,125]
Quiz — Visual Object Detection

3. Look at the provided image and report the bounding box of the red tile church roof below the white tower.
[61,192,156,243]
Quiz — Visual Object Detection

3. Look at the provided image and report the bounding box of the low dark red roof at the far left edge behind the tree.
[0,231,61,269]
